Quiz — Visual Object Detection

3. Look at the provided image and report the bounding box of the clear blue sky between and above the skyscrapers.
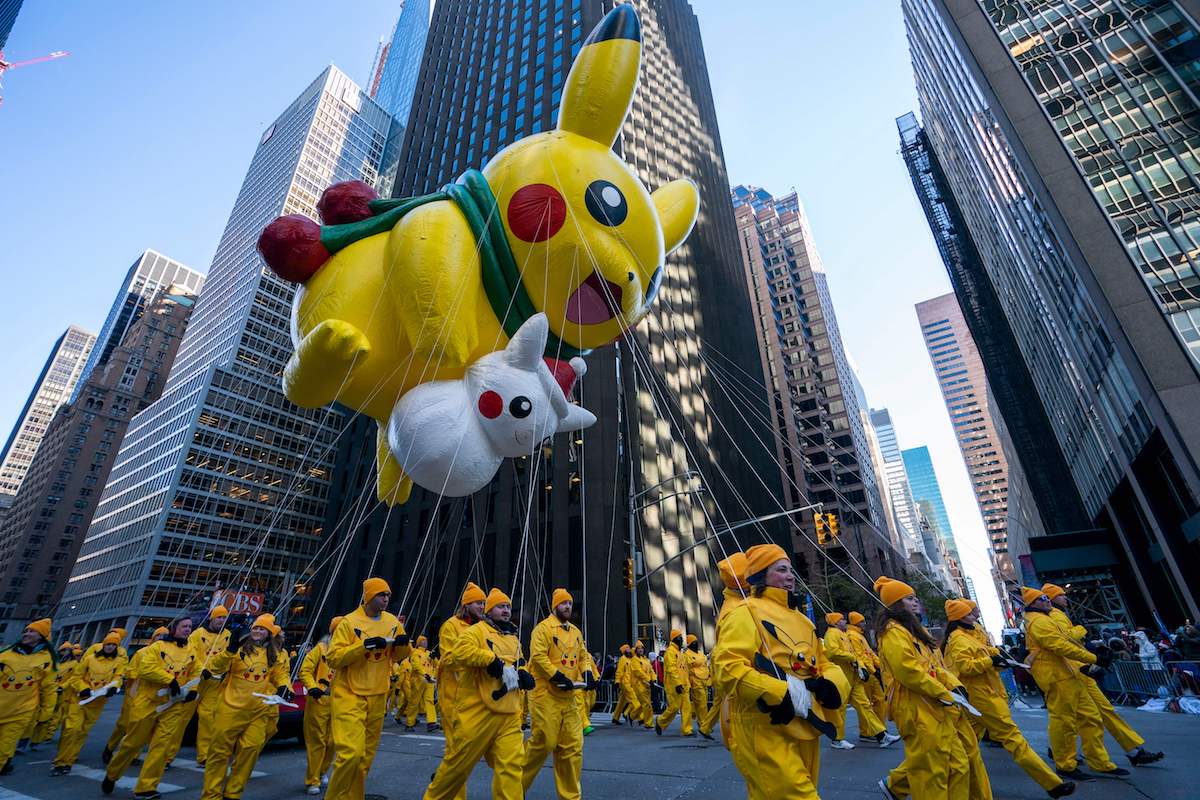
[0,0,998,627]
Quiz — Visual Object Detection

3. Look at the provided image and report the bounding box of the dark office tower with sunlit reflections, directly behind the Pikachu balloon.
[319,0,787,651]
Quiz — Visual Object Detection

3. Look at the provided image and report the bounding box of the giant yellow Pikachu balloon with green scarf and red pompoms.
[258,5,700,504]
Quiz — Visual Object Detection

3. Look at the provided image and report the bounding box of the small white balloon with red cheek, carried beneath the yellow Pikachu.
[388,314,596,497]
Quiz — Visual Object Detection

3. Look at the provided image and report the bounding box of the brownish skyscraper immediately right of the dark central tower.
[732,186,905,583]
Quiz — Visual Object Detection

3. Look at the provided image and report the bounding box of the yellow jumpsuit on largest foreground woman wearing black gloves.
[713,587,850,800]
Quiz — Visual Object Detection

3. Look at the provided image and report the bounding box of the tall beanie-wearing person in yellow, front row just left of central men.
[325,578,412,800]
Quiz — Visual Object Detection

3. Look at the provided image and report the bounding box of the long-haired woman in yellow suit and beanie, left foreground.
[200,614,292,800]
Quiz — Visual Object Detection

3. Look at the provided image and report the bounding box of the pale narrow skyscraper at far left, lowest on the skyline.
[0,325,96,506]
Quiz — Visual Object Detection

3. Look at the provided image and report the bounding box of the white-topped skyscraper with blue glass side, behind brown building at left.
[71,249,204,402]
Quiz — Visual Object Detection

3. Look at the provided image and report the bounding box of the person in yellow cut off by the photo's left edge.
[0,619,58,775]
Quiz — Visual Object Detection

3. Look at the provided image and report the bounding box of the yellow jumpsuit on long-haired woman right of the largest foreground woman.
[880,621,969,800]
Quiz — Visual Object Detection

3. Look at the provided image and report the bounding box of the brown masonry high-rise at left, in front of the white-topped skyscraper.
[0,285,196,644]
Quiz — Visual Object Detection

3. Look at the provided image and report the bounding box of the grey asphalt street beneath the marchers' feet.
[0,704,1200,800]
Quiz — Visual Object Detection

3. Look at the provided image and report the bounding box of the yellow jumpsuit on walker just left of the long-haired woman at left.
[106,639,200,793]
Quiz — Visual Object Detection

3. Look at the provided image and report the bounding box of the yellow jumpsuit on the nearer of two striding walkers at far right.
[1025,608,1116,772]
